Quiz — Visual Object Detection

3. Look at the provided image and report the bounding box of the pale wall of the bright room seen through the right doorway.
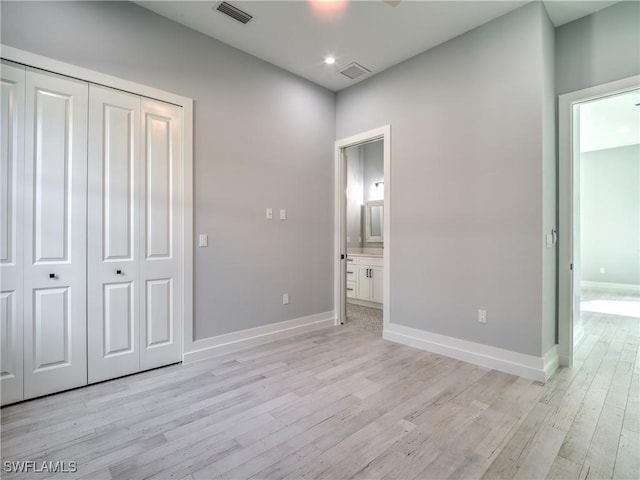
[580,145,640,285]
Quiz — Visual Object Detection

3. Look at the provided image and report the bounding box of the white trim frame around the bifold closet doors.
[0,44,195,360]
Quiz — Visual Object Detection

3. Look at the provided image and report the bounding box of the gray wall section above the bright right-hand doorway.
[556,1,640,94]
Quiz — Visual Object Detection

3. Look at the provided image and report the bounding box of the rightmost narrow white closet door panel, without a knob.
[140,99,182,370]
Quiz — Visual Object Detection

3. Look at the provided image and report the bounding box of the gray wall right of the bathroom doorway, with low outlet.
[336,3,555,356]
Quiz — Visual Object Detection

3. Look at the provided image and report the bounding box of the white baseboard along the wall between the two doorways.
[382,323,559,382]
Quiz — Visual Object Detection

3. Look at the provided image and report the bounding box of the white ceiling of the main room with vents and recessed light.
[134,0,617,91]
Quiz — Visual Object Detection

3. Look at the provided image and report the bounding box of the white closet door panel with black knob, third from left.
[88,85,141,383]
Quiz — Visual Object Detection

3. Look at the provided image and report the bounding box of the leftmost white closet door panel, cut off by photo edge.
[0,62,25,405]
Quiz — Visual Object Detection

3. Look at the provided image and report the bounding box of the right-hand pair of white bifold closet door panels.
[88,85,182,383]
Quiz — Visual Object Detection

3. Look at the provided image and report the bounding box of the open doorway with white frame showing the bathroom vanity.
[334,125,391,334]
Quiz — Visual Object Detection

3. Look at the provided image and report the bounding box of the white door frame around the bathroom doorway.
[333,125,391,331]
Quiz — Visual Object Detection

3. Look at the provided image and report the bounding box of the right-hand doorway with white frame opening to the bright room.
[558,76,640,367]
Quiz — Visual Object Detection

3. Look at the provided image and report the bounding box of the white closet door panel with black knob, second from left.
[24,69,88,398]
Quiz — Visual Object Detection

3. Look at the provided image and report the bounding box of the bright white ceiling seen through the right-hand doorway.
[580,89,640,152]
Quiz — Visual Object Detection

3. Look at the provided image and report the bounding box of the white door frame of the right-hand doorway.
[558,75,640,367]
